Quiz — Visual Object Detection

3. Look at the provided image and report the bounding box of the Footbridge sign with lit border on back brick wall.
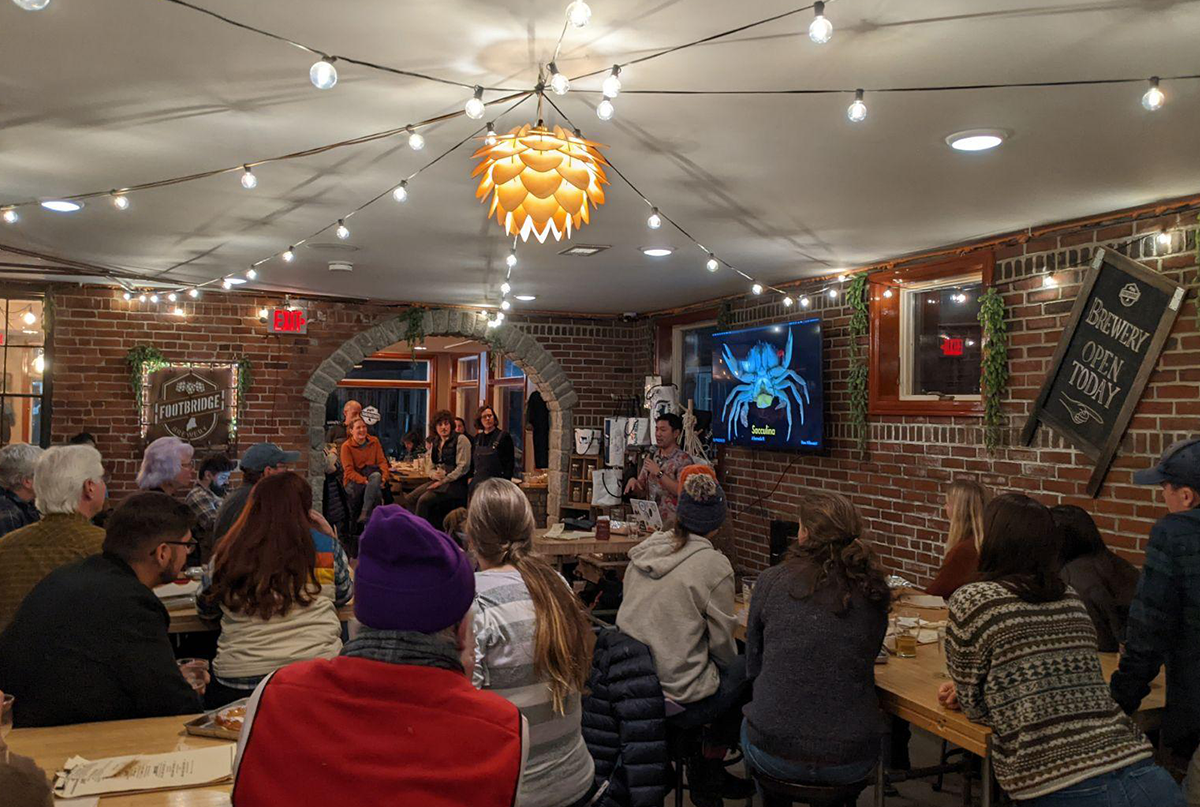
[145,365,235,449]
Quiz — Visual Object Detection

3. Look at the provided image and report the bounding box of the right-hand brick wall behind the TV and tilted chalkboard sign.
[686,202,1200,581]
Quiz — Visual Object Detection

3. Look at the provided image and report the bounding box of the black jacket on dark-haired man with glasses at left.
[0,554,203,728]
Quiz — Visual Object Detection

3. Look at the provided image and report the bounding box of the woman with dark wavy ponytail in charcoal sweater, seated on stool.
[742,491,890,784]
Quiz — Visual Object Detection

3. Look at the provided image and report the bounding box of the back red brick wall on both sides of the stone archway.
[50,286,649,497]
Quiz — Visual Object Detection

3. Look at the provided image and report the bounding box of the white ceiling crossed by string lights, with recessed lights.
[0,0,1200,312]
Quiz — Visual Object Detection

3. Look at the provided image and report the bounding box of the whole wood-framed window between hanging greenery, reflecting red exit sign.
[868,252,994,416]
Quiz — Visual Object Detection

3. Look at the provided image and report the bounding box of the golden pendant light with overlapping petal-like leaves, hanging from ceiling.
[472,121,608,244]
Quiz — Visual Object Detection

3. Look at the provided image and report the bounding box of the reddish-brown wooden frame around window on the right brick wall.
[868,251,996,417]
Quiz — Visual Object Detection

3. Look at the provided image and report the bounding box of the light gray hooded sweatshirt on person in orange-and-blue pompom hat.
[617,532,738,704]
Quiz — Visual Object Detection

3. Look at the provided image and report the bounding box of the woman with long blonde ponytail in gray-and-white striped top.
[466,478,595,807]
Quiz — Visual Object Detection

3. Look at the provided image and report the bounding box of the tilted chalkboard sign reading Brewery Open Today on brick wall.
[1021,247,1186,496]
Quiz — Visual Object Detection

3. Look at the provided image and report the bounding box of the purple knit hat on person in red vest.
[354,504,475,633]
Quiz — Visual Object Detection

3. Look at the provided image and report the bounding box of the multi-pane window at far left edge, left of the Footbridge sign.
[0,298,49,446]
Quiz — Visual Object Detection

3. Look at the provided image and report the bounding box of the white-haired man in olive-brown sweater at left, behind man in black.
[0,446,108,630]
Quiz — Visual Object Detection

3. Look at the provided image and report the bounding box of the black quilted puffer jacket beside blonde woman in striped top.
[583,630,673,807]
